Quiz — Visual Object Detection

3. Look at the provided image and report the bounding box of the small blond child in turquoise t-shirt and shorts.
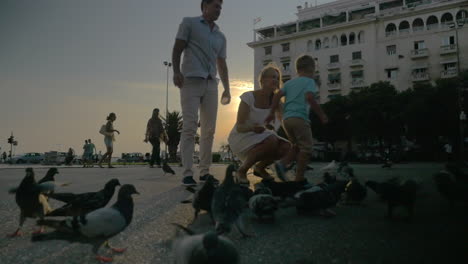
[265,55,328,185]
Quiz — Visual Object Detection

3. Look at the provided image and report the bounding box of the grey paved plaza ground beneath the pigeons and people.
[0,163,468,264]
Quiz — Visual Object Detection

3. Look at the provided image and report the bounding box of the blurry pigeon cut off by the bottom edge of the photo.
[172,224,240,264]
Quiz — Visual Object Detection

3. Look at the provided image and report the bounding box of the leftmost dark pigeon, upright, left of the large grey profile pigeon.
[9,168,51,237]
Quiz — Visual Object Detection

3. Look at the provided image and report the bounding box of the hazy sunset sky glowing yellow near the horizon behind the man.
[0,0,332,156]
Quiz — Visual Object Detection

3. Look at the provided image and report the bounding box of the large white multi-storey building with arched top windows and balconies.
[248,0,468,103]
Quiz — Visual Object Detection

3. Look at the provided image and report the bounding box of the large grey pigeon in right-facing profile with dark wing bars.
[31,184,139,262]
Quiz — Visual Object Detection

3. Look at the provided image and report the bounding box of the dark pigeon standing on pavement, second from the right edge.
[366,179,418,220]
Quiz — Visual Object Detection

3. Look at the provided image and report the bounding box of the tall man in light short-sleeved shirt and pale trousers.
[172,0,231,185]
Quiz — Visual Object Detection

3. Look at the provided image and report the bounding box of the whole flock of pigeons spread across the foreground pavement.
[8,161,468,264]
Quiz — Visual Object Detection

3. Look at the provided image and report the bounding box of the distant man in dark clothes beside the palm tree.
[144,108,164,168]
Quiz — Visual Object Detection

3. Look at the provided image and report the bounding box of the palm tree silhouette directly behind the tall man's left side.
[162,111,182,162]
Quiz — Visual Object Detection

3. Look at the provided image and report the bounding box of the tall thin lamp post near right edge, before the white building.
[449,12,466,162]
